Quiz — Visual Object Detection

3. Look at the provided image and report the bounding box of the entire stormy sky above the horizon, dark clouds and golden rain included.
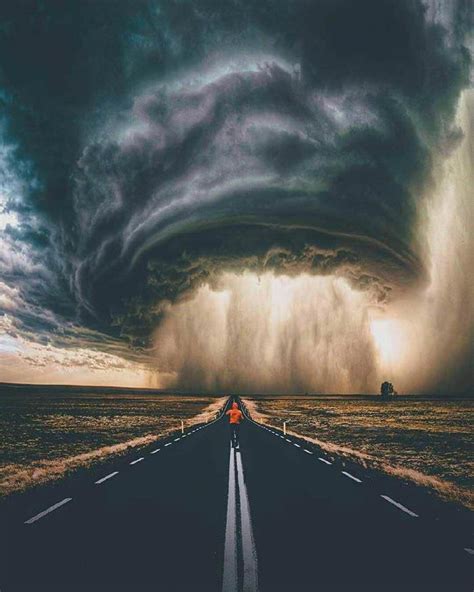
[0,0,474,394]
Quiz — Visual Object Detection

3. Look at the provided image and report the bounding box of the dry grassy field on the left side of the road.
[0,388,222,495]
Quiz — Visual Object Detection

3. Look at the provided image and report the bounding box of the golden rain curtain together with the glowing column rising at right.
[155,93,474,393]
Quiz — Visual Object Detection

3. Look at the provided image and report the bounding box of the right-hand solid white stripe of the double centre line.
[236,452,258,592]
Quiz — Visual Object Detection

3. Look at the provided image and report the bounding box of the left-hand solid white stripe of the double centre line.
[222,446,238,592]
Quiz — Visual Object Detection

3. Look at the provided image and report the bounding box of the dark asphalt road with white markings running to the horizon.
[0,398,474,592]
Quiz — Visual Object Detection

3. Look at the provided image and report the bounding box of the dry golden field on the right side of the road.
[246,396,474,507]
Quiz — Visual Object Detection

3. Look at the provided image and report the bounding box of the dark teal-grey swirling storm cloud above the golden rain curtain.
[0,0,471,390]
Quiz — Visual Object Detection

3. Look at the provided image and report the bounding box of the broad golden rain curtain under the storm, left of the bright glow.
[155,273,376,392]
